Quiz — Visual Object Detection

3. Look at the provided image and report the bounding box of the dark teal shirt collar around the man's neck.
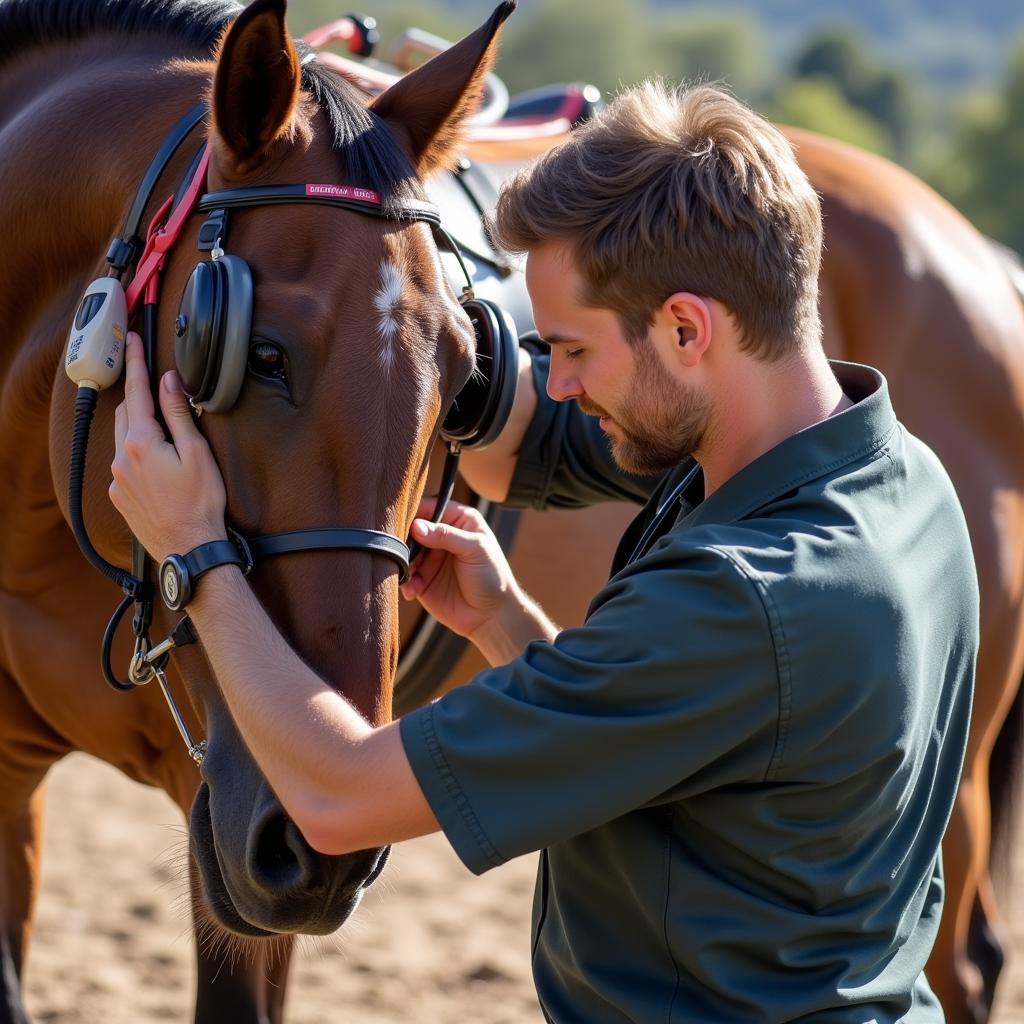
[678,359,896,527]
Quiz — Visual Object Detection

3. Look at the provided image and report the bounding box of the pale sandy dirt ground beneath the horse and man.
[18,755,1024,1024]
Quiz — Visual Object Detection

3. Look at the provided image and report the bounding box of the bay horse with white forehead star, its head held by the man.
[0,0,513,1024]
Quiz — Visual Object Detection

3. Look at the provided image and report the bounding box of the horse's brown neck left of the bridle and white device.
[0,41,207,540]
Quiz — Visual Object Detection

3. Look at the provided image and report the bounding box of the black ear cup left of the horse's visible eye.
[174,256,253,413]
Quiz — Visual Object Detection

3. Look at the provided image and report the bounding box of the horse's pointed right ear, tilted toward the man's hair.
[371,0,516,176]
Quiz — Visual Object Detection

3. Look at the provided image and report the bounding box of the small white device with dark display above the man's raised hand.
[65,278,128,392]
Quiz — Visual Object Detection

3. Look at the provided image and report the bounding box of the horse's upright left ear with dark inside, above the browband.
[212,0,302,173]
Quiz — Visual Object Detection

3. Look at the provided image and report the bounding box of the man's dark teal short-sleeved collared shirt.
[401,365,978,1024]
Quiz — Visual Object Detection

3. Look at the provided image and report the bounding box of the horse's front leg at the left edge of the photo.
[0,669,67,1024]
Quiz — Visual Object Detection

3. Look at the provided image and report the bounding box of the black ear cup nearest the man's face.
[440,299,519,450]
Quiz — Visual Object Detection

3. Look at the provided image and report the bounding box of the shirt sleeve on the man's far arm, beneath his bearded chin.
[505,334,662,509]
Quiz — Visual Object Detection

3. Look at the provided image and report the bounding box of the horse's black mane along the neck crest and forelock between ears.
[0,0,416,206]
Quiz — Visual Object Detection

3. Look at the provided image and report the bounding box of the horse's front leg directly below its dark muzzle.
[189,860,293,1024]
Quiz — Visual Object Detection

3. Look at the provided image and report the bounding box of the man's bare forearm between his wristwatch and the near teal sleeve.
[188,567,437,853]
